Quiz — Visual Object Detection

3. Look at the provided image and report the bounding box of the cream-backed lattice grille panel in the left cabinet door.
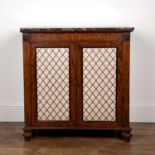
[36,48,69,121]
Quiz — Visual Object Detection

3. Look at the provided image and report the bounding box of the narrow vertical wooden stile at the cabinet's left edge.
[23,41,31,127]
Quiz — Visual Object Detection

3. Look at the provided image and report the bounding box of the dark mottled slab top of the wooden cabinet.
[20,27,134,33]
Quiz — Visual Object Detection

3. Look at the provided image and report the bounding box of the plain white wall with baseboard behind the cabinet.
[0,0,155,122]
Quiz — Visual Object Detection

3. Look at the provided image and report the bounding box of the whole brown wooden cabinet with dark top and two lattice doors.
[20,27,134,141]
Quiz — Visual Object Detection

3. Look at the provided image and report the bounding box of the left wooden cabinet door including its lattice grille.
[31,42,76,127]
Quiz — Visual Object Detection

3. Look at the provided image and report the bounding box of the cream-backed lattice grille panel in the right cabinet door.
[83,48,117,121]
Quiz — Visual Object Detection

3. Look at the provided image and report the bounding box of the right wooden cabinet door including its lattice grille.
[77,42,122,128]
